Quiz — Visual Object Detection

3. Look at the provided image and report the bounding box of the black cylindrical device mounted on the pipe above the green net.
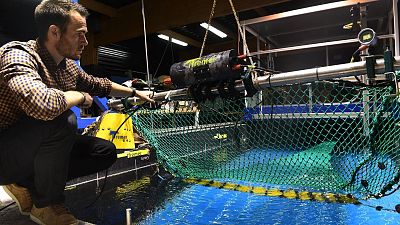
[170,49,253,102]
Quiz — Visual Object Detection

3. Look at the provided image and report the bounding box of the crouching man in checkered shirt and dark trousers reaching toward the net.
[0,0,153,225]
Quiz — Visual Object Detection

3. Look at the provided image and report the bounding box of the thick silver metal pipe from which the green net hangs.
[108,56,400,108]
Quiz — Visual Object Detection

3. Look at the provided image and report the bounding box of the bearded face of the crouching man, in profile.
[56,11,88,60]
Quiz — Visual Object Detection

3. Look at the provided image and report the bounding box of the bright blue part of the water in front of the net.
[139,181,400,225]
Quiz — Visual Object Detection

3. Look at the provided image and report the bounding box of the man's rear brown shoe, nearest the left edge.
[3,184,33,215]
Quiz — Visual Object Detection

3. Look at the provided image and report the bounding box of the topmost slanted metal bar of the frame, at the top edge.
[240,0,378,25]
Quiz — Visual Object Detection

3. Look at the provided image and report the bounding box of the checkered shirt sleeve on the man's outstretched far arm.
[68,60,112,97]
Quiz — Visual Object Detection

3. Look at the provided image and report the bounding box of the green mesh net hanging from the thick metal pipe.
[134,78,400,196]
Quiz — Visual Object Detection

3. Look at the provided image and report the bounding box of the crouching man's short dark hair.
[35,0,89,42]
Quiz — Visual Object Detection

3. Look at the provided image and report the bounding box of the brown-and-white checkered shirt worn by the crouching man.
[0,40,111,131]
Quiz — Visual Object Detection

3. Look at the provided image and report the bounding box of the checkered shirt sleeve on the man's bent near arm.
[0,48,67,120]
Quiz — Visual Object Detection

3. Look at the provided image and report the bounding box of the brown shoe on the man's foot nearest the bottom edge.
[31,204,78,225]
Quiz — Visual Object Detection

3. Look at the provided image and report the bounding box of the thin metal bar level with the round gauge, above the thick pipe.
[250,34,395,56]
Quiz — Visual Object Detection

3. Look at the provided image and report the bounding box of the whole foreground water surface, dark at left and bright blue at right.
[67,171,400,225]
